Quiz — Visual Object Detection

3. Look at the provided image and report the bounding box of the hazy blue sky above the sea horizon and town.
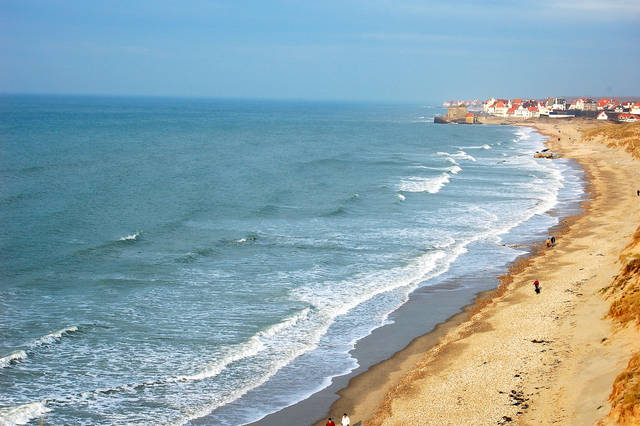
[0,0,640,102]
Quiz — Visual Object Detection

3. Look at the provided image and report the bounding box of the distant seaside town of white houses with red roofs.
[435,98,640,124]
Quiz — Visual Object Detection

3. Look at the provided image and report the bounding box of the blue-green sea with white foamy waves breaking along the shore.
[0,96,584,424]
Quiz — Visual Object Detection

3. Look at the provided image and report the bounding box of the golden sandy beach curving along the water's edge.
[319,119,640,425]
